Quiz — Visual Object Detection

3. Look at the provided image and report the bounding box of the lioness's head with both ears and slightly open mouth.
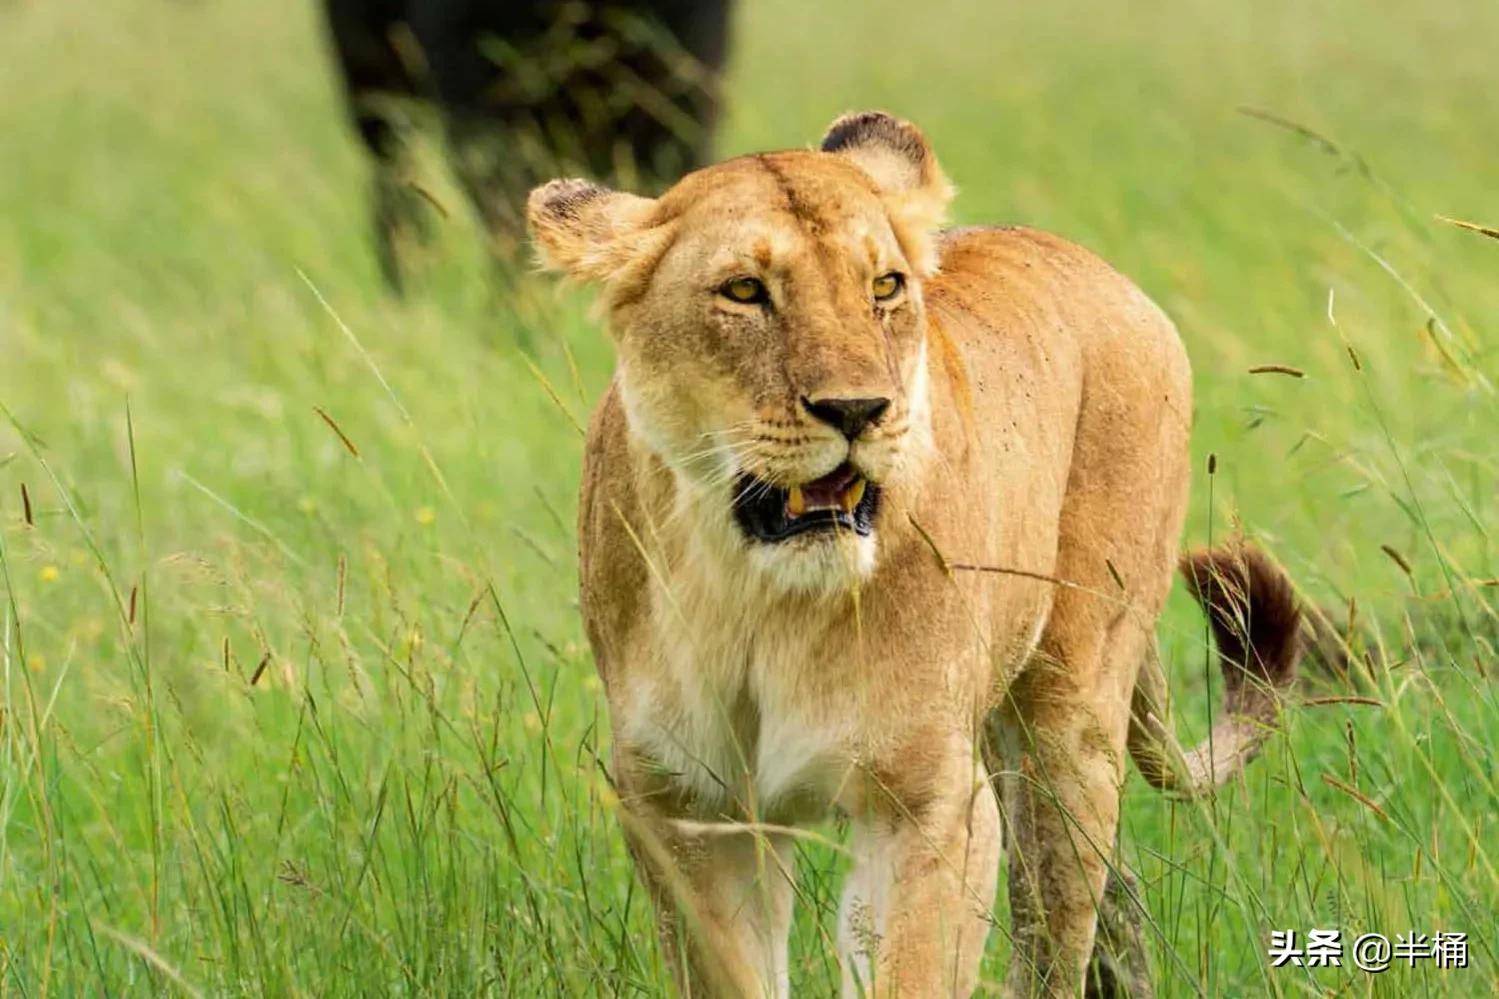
[528,113,952,588]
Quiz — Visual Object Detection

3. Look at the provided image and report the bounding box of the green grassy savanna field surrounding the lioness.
[0,0,1499,996]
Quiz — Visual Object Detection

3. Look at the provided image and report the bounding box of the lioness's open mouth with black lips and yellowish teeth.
[735,462,880,542]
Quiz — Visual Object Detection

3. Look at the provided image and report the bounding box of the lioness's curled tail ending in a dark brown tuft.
[1129,543,1301,797]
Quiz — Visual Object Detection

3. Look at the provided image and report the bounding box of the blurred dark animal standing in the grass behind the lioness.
[325,0,730,290]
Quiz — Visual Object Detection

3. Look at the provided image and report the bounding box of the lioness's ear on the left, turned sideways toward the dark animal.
[526,180,655,282]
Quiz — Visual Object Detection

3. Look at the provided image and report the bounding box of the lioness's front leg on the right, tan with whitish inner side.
[838,750,1001,996]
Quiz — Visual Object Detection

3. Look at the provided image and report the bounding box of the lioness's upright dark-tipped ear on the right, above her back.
[821,111,953,273]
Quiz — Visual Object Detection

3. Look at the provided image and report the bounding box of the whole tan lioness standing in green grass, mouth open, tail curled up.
[528,113,1298,996]
